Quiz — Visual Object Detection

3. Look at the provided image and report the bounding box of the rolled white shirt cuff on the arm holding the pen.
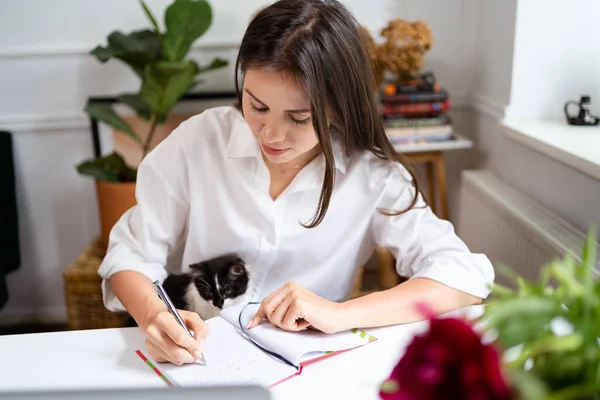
[98,260,167,312]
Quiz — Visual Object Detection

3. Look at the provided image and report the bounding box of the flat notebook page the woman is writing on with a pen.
[145,317,296,386]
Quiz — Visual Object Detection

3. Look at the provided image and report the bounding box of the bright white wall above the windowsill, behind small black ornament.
[507,0,600,119]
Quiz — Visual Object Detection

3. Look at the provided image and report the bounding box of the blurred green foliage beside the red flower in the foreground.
[483,228,600,400]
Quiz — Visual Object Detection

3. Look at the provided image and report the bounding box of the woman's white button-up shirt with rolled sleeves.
[99,107,494,311]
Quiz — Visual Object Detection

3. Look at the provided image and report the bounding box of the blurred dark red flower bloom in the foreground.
[380,304,513,400]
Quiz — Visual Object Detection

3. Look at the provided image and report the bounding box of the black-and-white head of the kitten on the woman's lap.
[190,254,249,308]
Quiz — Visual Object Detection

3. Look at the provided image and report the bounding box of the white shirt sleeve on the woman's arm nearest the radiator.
[371,161,494,298]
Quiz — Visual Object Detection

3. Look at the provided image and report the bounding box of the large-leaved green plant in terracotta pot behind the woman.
[77,0,228,246]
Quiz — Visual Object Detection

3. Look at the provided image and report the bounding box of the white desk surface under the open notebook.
[0,306,482,400]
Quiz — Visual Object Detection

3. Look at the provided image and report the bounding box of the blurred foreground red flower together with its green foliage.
[380,229,600,400]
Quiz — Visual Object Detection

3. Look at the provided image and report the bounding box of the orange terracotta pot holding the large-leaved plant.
[96,181,136,249]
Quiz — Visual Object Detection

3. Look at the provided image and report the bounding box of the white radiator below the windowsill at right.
[456,170,600,284]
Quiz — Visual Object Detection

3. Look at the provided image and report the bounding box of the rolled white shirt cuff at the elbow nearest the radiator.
[410,254,494,299]
